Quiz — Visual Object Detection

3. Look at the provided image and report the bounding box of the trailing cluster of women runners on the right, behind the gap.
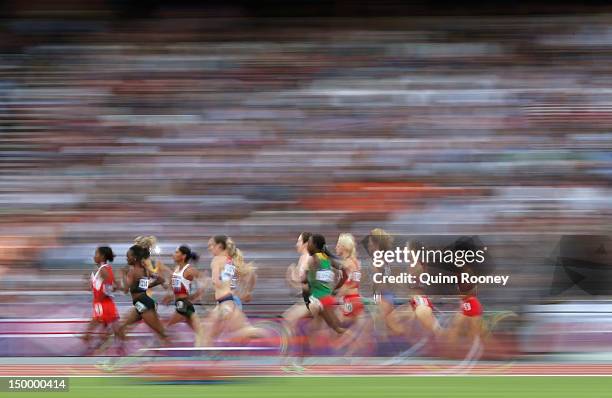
[284,228,483,351]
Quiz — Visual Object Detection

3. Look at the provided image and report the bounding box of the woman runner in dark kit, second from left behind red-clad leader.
[117,245,169,345]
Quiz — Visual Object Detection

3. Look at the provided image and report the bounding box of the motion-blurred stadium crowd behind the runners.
[0,0,612,355]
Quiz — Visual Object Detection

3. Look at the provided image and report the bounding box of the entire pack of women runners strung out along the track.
[83,229,483,356]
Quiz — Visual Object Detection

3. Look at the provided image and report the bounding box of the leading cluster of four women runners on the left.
[83,235,259,351]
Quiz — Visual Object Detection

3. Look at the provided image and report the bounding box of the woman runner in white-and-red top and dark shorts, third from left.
[163,245,204,347]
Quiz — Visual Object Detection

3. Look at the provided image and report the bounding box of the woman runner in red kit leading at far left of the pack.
[83,246,119,349]
